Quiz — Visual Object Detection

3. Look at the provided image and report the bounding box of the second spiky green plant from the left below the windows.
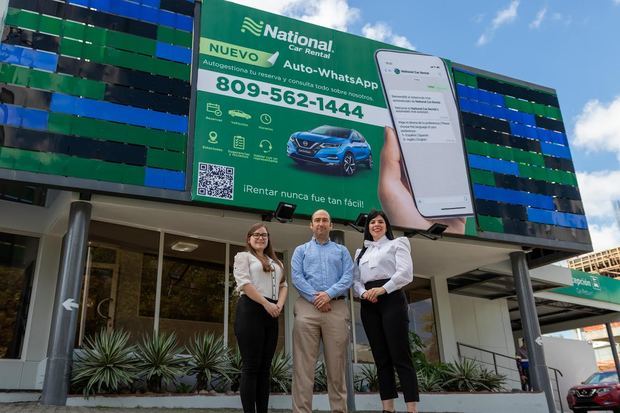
[137,333,187,393]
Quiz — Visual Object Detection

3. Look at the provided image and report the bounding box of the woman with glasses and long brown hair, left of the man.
[233,223,288,413]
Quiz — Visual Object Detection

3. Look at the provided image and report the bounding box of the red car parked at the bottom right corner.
[566,370,620,413]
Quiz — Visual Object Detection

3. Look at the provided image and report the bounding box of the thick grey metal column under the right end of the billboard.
[510,251,559,413]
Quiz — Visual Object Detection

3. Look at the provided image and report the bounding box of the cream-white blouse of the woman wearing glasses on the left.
[233,251,288,300]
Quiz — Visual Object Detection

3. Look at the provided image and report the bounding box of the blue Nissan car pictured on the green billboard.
[286,125,372,176]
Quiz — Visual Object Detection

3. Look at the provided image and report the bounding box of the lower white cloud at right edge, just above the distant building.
[577,170,620,220]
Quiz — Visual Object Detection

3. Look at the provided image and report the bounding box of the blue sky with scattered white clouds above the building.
[231,0,620,251]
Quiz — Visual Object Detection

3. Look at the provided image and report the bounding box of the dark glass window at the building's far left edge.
[0,233,39,359]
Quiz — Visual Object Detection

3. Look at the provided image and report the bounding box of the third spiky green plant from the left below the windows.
[187,333,232,391]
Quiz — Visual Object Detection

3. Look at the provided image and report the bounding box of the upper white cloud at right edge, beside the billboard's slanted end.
[573,96,620,160]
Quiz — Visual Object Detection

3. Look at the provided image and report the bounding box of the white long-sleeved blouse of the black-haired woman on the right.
[353,235,413,297]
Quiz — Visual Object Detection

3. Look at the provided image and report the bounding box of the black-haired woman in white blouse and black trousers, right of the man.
[353,210,420,413]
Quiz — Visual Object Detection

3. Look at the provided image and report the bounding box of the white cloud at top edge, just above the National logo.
[225,0,360,31]
